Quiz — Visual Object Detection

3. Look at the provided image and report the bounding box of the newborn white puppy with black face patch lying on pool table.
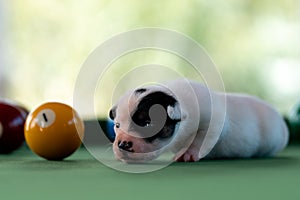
[109,79,288,163]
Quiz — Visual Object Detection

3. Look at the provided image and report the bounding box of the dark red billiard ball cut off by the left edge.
[0,100,28,154]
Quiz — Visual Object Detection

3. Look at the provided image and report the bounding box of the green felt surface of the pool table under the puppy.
[0,145,300,200]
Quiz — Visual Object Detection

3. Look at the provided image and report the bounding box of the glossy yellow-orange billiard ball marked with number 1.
[25,102,84,160]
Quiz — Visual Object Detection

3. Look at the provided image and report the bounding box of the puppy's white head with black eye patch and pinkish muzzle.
[109,86,181,163]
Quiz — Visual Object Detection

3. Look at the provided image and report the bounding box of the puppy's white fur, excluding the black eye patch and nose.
[113,80,288,162]
